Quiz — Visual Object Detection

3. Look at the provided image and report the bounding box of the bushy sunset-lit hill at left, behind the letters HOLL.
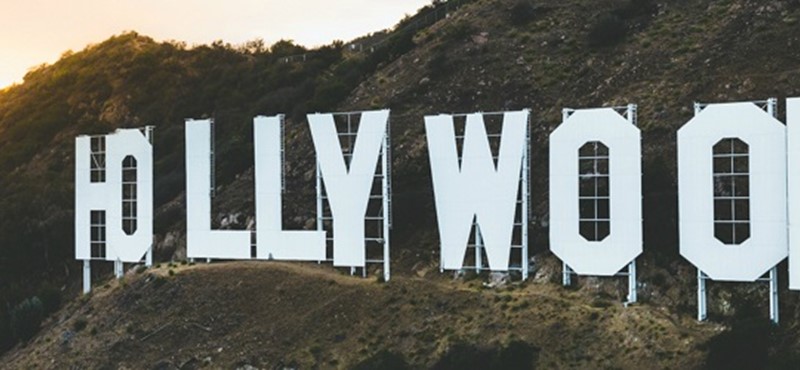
[0,1,468,350]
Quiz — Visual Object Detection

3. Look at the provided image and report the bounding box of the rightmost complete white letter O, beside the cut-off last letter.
[678,103,788,282]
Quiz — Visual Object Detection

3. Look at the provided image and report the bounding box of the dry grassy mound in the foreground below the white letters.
[2,262,720,369]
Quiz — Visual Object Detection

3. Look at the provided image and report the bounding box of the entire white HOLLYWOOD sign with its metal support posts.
[75,98,800,322]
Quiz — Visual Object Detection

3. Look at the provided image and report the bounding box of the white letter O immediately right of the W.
[550,108,642,276]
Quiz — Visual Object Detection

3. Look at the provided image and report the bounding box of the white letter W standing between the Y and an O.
[425,110,529,271]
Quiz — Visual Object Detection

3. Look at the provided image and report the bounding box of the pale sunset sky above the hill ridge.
[0,0,431,88]
